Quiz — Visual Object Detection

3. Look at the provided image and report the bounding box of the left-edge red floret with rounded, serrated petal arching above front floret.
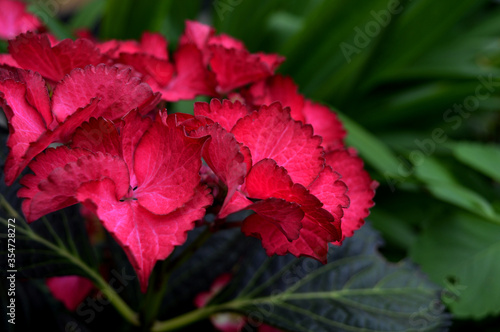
[0,65,159,184]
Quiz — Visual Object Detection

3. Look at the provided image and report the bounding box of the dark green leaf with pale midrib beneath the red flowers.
[207,225,447,332]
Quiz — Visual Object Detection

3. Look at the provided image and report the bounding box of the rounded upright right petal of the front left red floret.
[134,116,208,214]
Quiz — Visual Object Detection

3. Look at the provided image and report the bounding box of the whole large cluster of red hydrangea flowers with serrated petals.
[0,15,376,290]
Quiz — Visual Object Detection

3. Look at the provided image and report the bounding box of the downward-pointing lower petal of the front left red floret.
[77,178,212,292]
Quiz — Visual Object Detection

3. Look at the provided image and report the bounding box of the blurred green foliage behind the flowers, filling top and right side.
[34,0,500,331]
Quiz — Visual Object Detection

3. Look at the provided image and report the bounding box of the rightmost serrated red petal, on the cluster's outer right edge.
[326,149,378,244]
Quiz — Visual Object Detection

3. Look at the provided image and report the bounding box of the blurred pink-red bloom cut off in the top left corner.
[0,0,42,39]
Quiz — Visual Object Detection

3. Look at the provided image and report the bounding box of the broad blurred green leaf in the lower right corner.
[411,213,500,319]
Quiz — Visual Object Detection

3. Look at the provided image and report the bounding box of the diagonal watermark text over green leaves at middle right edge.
[384,74,500,192]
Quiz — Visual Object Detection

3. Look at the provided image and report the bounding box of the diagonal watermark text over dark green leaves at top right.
[340,0,404,63]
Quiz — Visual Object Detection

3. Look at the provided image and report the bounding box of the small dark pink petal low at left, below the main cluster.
[45,275,94,311]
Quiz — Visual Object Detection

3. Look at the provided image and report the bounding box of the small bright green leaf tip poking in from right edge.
[450,142,500,182]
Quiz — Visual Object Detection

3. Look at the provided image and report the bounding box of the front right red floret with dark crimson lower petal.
[190,100,349,261]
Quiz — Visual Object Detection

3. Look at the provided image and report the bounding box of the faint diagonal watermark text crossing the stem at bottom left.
[64,268,137,332]
